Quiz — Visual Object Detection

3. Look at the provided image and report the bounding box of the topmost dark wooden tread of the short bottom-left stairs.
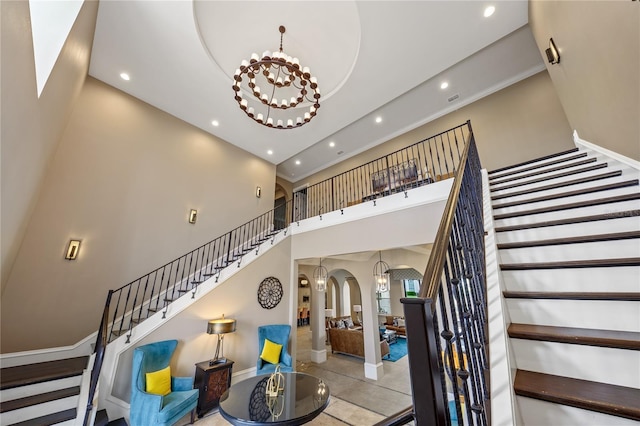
[0,356,89,389]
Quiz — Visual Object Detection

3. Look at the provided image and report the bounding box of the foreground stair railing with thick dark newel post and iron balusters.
[400,122,490,425]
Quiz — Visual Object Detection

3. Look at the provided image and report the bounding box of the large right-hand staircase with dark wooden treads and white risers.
[489,148,640,425]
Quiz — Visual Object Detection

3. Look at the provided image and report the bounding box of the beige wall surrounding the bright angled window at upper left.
[0,1,98,290]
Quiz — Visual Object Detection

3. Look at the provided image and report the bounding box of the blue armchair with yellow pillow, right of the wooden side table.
[256,324,293,374]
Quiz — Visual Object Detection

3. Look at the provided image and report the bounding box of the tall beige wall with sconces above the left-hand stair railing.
[2,78,275,352]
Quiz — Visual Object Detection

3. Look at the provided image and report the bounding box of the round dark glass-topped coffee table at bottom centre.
[220,373,329,425]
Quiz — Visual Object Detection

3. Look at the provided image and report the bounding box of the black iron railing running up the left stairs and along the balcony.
[89,123,470,424]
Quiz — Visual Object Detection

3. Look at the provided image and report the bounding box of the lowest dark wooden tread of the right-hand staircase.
[513,370,640,420]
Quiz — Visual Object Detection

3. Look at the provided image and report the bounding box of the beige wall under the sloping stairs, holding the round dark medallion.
[112,239,297,401]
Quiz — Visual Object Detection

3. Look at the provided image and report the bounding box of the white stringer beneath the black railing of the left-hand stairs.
[96,225,294,424]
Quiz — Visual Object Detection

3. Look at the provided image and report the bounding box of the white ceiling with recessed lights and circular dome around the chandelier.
[89,0,544,182]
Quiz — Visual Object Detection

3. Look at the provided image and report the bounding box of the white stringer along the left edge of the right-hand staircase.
[482,169,522,426]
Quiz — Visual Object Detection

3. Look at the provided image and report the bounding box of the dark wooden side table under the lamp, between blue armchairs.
[195,358,233,417]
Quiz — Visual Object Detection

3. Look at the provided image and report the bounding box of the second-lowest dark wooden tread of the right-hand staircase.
[507,323,640,351]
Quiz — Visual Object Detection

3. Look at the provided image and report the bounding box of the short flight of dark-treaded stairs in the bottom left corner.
[0,357,89,426]
